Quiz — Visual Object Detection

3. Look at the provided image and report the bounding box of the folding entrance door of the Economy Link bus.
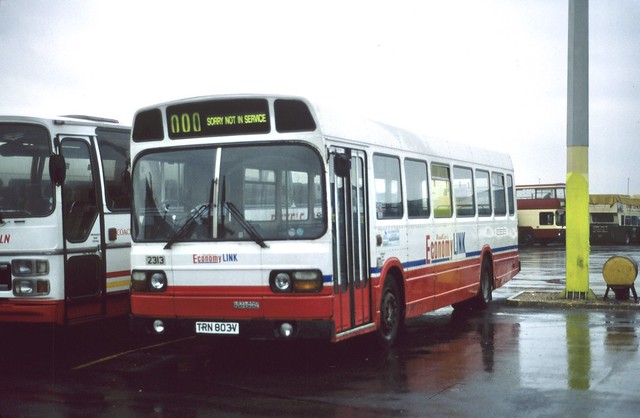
[331,149,371,332]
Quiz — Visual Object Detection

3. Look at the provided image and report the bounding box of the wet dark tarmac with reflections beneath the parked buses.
[0,246,640,418]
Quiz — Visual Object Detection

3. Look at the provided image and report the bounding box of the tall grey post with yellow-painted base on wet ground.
[565,0,592,299]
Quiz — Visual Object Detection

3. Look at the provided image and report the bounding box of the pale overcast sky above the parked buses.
[0,0,640,194]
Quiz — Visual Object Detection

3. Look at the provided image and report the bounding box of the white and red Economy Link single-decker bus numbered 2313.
[131,95,520,345]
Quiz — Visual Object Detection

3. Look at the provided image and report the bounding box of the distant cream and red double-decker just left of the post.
[516,183,566,245]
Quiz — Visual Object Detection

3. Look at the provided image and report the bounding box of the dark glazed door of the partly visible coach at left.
[61,137,104,322]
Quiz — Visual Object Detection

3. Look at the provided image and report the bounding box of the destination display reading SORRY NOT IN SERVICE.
[166,99,271,139]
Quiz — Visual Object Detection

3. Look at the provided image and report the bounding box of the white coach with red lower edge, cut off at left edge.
[0,116,131,325]
